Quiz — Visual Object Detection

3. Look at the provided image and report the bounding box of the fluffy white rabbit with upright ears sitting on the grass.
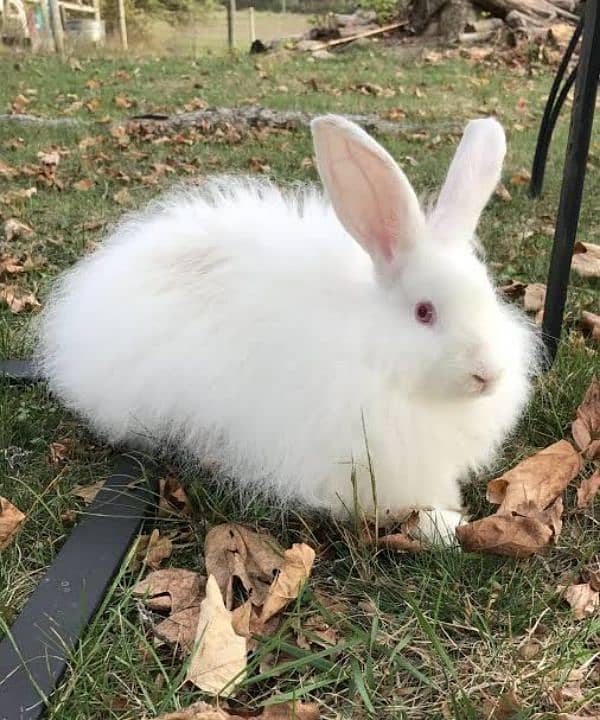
[39,115,537,534]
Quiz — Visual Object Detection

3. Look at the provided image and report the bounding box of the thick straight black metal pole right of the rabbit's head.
[543,0,600,366]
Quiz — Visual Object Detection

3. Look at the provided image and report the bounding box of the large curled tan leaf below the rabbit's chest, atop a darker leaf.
[487,440,581,515]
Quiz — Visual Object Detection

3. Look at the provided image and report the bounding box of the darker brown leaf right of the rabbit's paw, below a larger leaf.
[456,515,553,558]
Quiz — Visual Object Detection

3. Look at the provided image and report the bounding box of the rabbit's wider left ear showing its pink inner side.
[311,115,425,265]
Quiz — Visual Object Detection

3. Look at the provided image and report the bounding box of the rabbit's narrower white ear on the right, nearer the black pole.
[430,118,506,241]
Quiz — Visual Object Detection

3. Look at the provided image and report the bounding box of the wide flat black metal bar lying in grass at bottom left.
[0,455,155,720]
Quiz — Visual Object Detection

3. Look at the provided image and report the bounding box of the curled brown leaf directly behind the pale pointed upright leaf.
[204,523,283,609]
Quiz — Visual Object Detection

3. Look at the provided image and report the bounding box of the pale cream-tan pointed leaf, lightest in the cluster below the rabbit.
[186,575,247,697]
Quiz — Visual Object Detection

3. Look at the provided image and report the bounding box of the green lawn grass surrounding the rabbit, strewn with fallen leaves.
[0,46,600,720]
